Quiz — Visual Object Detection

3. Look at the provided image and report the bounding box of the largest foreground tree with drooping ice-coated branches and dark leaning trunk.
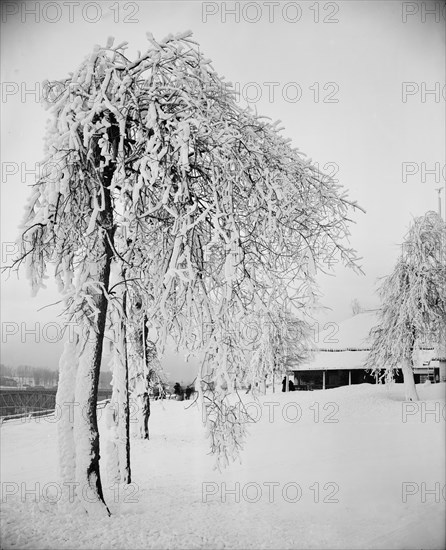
[12,33,357,511]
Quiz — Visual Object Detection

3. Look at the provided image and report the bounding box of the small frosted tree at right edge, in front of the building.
[366,212,446,401]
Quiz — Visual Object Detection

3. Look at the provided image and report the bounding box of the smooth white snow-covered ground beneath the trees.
[1,384,446,550]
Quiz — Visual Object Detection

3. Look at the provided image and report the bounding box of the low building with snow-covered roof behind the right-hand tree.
[289,310,446,390]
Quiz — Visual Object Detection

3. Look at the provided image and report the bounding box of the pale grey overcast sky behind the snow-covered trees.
[1,0,446,382]
